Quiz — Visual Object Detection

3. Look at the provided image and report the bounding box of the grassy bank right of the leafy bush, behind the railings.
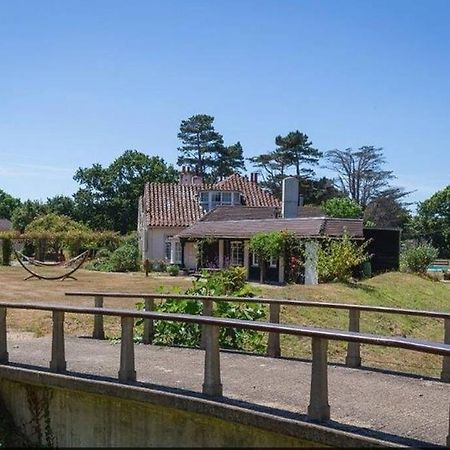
[262,272,450,376]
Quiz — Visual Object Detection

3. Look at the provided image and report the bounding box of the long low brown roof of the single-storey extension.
[174,217,363,239]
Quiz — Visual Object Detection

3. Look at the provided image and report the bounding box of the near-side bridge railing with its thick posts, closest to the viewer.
[0,302,450,443]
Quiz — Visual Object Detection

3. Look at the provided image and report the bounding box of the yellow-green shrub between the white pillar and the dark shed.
[317,233,370,282]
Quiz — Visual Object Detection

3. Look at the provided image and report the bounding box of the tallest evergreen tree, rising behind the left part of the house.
[177,114,223,177]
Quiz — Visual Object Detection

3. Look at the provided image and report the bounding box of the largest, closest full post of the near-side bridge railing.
[308,337,330,422]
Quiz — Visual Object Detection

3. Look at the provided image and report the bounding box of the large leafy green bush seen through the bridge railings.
[136,267,266,353]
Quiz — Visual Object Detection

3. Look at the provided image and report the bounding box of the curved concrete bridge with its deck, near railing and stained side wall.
[0,302,450,447]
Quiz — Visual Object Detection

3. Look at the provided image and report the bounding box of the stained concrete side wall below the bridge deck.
[0,366,386,448]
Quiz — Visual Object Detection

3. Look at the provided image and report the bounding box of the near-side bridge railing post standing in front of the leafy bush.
[203,325,222,397]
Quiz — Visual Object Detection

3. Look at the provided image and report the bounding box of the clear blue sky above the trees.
[0,0,450,207]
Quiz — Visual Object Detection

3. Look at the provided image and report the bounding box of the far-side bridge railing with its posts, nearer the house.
[65,291,450,382]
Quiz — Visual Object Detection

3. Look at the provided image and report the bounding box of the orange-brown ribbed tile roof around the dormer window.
[143,174,281,227]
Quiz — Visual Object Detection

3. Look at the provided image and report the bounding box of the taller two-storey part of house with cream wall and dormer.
[138,167,281,269]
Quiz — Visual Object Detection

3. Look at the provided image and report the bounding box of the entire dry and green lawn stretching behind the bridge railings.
[0,267,450,376]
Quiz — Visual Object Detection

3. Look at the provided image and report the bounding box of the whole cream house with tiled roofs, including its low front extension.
[138,173,399,284]
